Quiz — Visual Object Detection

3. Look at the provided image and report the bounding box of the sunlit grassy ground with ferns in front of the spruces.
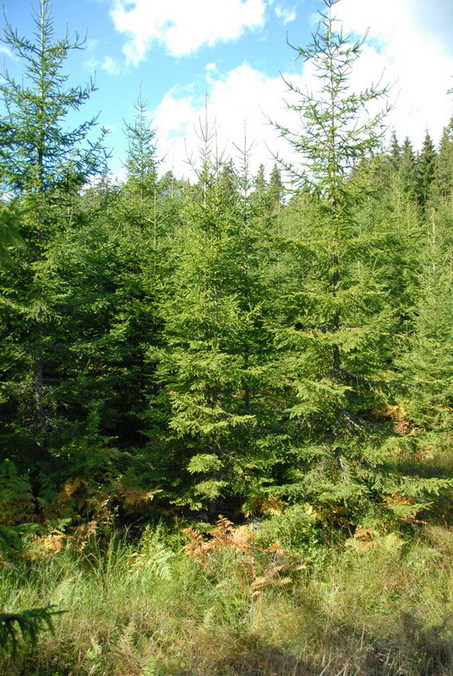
[0,522,453,676]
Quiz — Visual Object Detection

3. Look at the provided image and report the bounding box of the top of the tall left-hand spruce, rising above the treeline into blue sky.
[0,0,104,195]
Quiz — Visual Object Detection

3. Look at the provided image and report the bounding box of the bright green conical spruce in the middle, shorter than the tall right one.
[147,126,275,518]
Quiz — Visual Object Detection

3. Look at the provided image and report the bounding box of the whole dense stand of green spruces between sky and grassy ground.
[0,0,453,673]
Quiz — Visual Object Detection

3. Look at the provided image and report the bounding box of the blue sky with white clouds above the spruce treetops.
[0,0,453,178]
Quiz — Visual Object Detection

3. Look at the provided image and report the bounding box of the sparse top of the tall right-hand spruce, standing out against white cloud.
[276,0,387,190]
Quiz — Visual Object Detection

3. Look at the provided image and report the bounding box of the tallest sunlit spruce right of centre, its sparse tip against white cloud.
[275,0,430,519]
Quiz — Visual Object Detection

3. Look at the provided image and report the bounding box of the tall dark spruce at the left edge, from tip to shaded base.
[0,0,105,508]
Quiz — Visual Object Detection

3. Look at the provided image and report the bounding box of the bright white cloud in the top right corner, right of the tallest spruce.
[335,0,453,147]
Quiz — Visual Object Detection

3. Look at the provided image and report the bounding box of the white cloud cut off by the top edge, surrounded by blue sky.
[110,0,266,65]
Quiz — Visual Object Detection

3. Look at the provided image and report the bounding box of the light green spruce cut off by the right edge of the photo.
[402,115,453,434]
